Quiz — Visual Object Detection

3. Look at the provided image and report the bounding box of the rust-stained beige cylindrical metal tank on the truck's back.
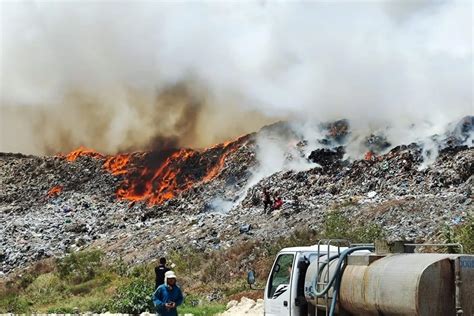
[305,253,474,316]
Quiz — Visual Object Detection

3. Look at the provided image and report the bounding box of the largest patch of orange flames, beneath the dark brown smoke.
[62,138,243,205]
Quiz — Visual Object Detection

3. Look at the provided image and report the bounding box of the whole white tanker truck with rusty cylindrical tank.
[260,241,474,316]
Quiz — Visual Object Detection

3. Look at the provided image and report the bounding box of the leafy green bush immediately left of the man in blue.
[110,278,154,314]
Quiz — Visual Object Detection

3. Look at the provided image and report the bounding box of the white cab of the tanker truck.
[264,246,345,316]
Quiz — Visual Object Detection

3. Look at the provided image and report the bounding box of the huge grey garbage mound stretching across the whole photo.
[0,117,474,275]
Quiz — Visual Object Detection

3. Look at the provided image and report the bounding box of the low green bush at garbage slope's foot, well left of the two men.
[56,250,104,284]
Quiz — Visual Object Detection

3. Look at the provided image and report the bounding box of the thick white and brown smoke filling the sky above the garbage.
[0,1,474,153]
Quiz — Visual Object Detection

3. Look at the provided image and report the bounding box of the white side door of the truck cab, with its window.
[265,254,295,316]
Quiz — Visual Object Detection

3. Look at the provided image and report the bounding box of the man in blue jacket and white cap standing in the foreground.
[152,270,184,316]
